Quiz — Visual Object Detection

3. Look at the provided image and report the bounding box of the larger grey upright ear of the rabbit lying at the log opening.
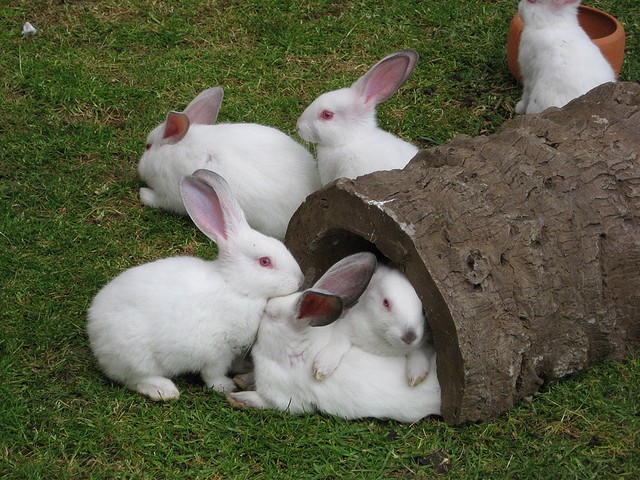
[313,252,377,308]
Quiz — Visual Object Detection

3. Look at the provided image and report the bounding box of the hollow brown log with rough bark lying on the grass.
[286,83,640,424]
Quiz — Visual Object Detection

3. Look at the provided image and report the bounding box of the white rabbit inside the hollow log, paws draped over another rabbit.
[313,264,431,387]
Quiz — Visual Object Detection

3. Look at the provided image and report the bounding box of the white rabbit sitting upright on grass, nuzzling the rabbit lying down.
[87,170,303,400]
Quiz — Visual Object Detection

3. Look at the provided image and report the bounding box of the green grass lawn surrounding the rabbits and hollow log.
[0,0,640,479]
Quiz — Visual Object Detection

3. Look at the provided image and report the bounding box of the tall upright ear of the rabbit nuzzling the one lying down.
[180,170,247,246]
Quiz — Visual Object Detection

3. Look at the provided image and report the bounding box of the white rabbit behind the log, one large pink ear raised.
[297,50,418,185]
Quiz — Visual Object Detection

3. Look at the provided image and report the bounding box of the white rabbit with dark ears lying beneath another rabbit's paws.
[227,253,441,422]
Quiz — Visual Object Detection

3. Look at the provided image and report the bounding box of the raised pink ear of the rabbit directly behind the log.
[351,50,418,105]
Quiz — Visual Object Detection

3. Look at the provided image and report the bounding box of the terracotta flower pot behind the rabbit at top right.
[507,5,625,82]
